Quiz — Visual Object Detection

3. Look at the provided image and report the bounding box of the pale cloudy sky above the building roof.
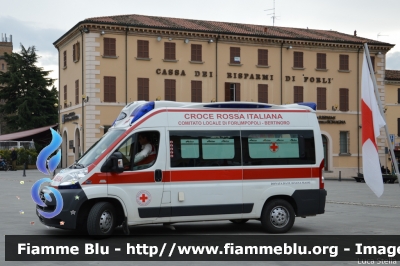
[0,0,400,89]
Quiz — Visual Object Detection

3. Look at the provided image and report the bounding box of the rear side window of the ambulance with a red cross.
[242,130,315,165]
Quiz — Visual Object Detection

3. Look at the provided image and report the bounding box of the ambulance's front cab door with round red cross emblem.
[108,127,170,224]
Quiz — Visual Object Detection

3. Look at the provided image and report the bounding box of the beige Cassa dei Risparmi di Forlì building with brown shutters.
[54,15,397,177]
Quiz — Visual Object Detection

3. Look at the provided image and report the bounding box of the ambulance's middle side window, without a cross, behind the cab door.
[170,131,241,167]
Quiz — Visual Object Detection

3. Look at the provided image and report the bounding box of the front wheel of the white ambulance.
[87,202,116,238]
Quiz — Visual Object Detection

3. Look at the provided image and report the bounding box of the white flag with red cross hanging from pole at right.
[361,51,385,197]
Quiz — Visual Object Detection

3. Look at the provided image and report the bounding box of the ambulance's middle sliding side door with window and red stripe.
[167,129,244,222]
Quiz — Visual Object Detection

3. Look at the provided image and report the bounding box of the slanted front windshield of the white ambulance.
[72,130,125,168]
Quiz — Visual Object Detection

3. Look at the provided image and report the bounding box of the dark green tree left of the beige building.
[0,44,58,134]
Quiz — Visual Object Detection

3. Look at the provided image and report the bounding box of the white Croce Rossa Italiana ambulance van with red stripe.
[36,101,327,236]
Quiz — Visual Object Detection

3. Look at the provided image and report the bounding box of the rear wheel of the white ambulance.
[261,199,295,234]
